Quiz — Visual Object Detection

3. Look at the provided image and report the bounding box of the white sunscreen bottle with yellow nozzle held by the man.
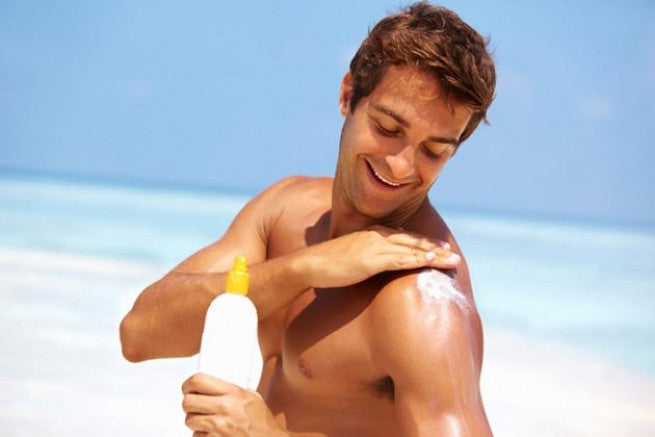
[198,256,263,390]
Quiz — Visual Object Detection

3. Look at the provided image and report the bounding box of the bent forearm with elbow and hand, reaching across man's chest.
[121,227,458,361]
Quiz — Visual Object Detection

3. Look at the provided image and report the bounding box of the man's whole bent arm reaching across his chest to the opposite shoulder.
[120,177,459,361]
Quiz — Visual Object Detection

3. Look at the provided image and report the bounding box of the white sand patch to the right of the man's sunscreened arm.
[482,327,655,437]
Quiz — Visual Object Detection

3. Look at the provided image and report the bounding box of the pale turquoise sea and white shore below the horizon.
[0,175,655,436]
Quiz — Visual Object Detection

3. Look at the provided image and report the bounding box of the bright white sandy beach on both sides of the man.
[0,249,655,437]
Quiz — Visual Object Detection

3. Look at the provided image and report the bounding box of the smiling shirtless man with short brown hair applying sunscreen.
[121,3,495,437]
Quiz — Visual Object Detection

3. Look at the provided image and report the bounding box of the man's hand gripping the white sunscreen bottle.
[182,373,288,437]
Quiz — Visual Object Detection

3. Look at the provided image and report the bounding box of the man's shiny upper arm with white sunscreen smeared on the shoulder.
[372,271,492,437]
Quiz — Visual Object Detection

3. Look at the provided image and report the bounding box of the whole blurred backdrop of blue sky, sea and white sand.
[0,0,655,436]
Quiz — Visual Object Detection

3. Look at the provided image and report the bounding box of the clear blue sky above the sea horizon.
[0,0,655,224]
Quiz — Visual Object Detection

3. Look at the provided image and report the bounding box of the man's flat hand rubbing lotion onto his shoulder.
[295,226,461,288]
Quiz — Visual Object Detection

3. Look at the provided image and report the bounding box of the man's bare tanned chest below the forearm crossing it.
[266,287,397,436]
